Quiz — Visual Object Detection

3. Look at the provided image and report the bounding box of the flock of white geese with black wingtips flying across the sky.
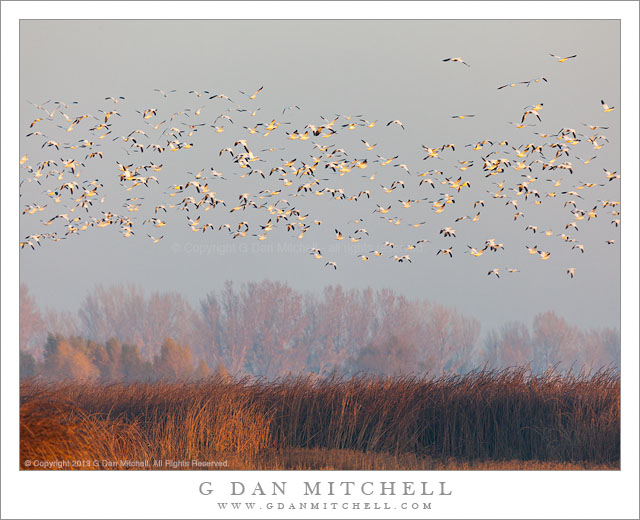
[20,54,620,278]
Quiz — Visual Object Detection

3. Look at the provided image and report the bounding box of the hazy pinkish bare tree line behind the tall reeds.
[20,280,620,381]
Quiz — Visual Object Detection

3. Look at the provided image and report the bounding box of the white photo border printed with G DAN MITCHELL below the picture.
[1,1,639,518]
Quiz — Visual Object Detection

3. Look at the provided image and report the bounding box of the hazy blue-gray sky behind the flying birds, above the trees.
[20,20,620,327]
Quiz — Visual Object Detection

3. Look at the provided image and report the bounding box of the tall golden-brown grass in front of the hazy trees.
[21,368,620,469]
